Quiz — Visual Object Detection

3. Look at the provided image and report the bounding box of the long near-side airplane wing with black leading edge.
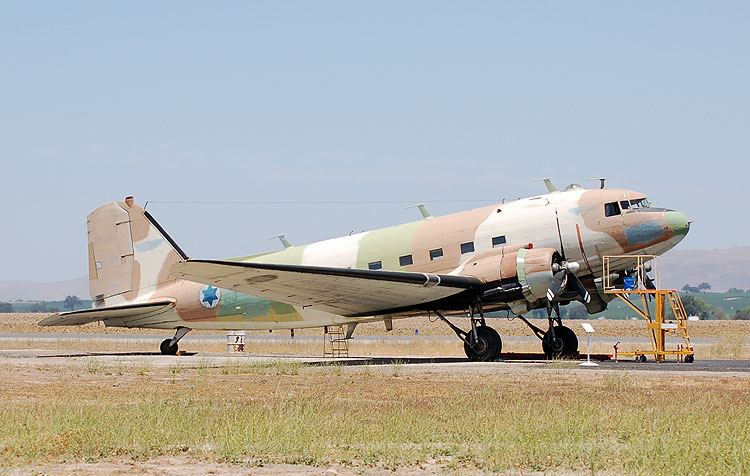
[170,260,484,317]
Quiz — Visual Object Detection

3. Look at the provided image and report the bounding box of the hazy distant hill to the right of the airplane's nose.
[661,246,750,292]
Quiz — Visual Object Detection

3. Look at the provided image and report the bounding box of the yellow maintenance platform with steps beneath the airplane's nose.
[603,255,694,363]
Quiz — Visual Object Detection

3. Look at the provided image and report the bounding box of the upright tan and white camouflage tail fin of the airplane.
[88,197,187,307]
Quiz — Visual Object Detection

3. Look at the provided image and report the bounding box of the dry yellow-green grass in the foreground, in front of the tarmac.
[0,359,750,475]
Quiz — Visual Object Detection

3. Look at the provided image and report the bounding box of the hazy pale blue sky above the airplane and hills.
[0,0,750,281]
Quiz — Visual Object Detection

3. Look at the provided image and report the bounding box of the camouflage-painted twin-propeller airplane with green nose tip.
[39,179,691,361]
